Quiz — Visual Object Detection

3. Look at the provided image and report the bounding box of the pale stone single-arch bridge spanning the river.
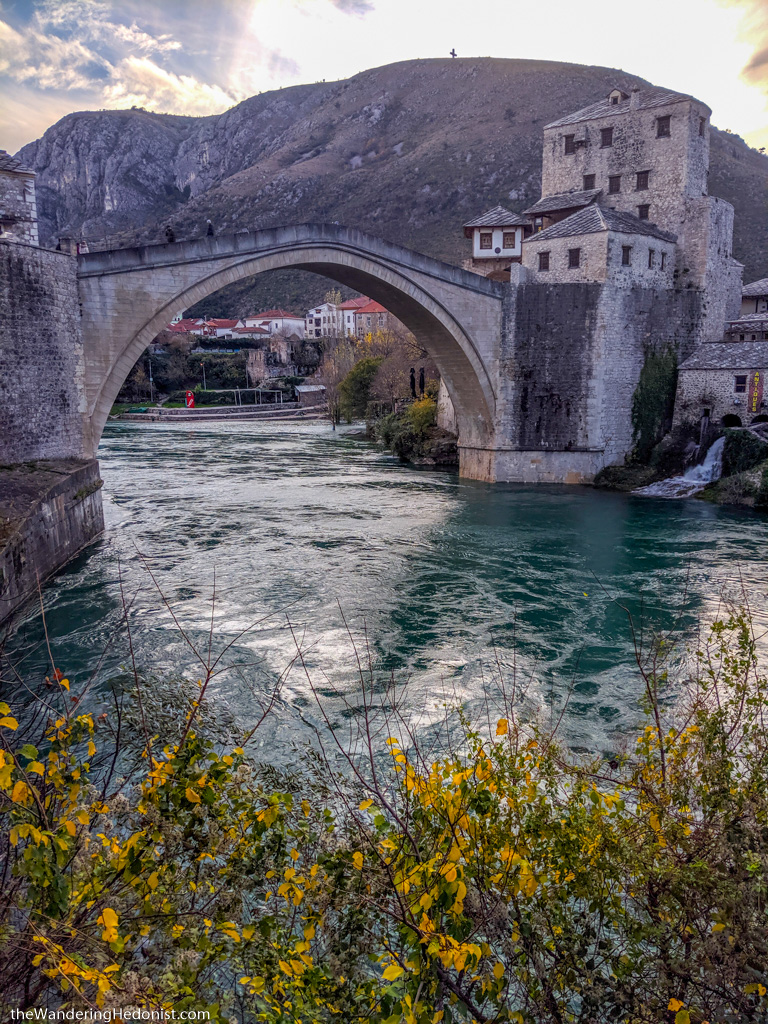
[78,225,503,468]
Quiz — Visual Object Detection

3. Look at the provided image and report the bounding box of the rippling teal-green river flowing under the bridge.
[3,423,768,759]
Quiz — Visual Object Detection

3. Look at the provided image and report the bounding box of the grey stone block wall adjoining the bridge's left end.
[0,240,90,464]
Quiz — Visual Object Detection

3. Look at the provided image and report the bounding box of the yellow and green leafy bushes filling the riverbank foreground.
[0,608,768,1024]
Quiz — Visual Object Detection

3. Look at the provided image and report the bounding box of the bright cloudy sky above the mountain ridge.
[0,0,768,153]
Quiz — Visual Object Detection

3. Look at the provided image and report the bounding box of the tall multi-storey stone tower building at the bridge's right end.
[450,87,745,482]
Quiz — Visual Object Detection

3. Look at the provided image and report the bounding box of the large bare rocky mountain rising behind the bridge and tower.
[18,58,768,281]
